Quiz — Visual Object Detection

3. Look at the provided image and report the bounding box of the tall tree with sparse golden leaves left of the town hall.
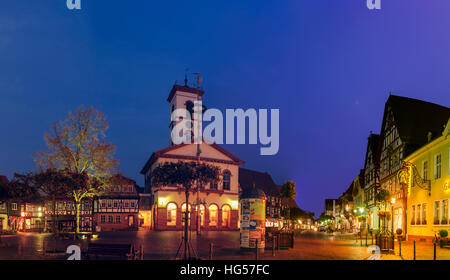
[35,106,119,233]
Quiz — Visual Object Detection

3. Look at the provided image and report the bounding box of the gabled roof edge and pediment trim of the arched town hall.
[140,142,244,174]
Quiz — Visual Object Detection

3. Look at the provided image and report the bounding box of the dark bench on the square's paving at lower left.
[86,243,135,260]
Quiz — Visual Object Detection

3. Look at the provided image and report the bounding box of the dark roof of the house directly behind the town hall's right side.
[239,168,281,196]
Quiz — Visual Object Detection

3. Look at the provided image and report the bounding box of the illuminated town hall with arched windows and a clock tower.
[141,85,243,231]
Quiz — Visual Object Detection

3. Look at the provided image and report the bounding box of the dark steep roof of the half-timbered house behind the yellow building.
[378,95,450,158]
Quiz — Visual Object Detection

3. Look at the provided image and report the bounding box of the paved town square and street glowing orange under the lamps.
[0,231,450,260]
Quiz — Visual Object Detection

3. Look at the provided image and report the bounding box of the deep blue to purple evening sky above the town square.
[0,0,450,215]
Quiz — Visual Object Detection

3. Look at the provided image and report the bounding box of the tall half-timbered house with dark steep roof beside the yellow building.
[377,95,450,235]
